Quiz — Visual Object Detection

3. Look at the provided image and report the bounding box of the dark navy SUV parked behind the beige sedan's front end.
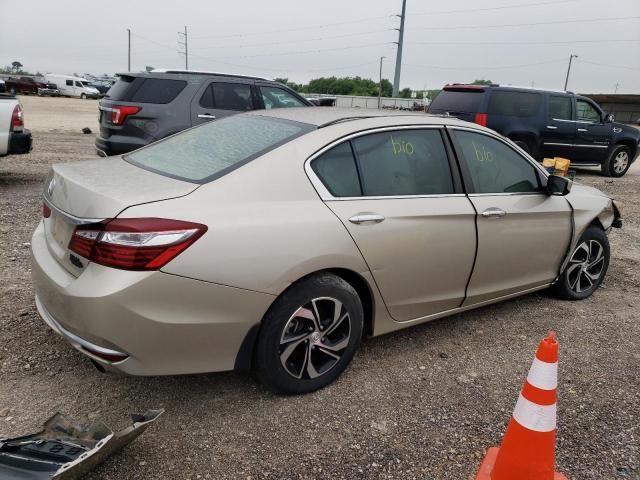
[428,84,640,177]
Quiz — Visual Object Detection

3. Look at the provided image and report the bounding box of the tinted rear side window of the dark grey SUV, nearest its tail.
[106,75,187,104]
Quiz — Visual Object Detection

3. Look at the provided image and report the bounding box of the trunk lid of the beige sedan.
[43,157,198,276]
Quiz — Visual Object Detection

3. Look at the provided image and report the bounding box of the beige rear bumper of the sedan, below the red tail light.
[31,222,274,375]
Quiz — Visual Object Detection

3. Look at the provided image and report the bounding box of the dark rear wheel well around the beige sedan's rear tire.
[234,268,374,372]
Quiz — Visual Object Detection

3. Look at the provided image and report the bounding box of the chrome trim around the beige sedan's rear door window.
[304,124,465,201]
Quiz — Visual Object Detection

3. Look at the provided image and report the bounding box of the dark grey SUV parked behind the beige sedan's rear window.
[96,70,312,156]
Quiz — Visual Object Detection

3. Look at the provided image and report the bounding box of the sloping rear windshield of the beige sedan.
[124,115,314,183]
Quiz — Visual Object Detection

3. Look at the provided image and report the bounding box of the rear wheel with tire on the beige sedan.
[253,273,364,394]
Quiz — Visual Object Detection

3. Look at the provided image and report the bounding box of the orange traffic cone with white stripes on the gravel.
[476,332,567,480]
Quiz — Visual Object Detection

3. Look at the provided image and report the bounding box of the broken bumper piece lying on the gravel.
[0,410,164,480]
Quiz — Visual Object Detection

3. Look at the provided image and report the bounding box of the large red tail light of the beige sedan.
[69,218,207,270]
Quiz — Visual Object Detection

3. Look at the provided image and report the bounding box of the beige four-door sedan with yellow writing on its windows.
[31,108,621,393]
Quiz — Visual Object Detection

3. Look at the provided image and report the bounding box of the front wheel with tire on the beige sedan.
[552,226,611,300]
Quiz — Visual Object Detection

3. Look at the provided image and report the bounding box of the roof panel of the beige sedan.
[247,107,482,129]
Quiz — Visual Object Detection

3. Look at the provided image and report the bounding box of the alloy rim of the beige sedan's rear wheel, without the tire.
[279,297,351,380]
